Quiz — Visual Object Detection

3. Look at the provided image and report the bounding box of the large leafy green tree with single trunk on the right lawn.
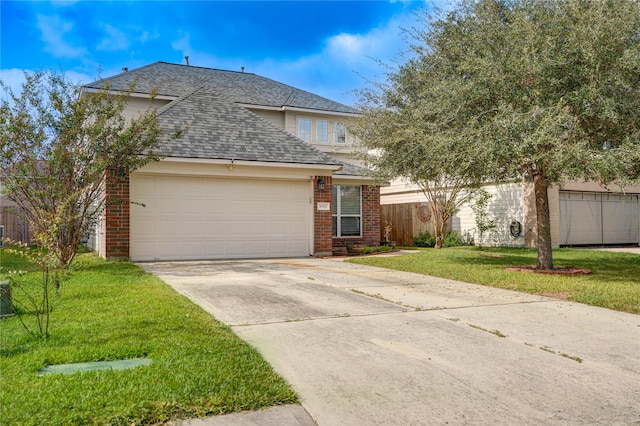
[356,0,640,269]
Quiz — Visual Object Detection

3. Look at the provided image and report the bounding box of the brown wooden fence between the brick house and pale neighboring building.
[380,203,433,246]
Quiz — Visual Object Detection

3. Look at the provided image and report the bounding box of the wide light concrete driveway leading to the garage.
[140,258,640,426]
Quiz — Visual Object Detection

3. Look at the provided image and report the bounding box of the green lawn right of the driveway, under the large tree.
[349,247,640,314]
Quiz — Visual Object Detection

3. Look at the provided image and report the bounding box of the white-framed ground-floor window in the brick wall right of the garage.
[331,185,362,237]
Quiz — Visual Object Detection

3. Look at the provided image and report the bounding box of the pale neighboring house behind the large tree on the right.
[380,180,640,247]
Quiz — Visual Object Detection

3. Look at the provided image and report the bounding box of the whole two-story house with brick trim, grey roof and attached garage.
[85,62,380,261]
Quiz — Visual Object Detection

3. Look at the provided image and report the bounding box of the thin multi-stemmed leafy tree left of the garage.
[0,72,171,268]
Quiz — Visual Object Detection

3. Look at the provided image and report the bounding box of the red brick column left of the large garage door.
[104,172,130,260]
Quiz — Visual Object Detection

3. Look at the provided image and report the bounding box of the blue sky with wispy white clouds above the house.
[0,0,446,104]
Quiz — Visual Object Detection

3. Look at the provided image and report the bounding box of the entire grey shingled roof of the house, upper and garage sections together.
[85,62,365,176]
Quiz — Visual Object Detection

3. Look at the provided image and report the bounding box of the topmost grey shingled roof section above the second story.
[85,62,356,114]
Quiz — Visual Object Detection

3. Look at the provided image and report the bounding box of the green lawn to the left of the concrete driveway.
[0,254,297,425]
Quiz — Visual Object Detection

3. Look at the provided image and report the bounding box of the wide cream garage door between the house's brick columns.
[130,174,311,261]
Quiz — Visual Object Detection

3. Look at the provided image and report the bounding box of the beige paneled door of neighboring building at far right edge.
[560,191,640,245]
